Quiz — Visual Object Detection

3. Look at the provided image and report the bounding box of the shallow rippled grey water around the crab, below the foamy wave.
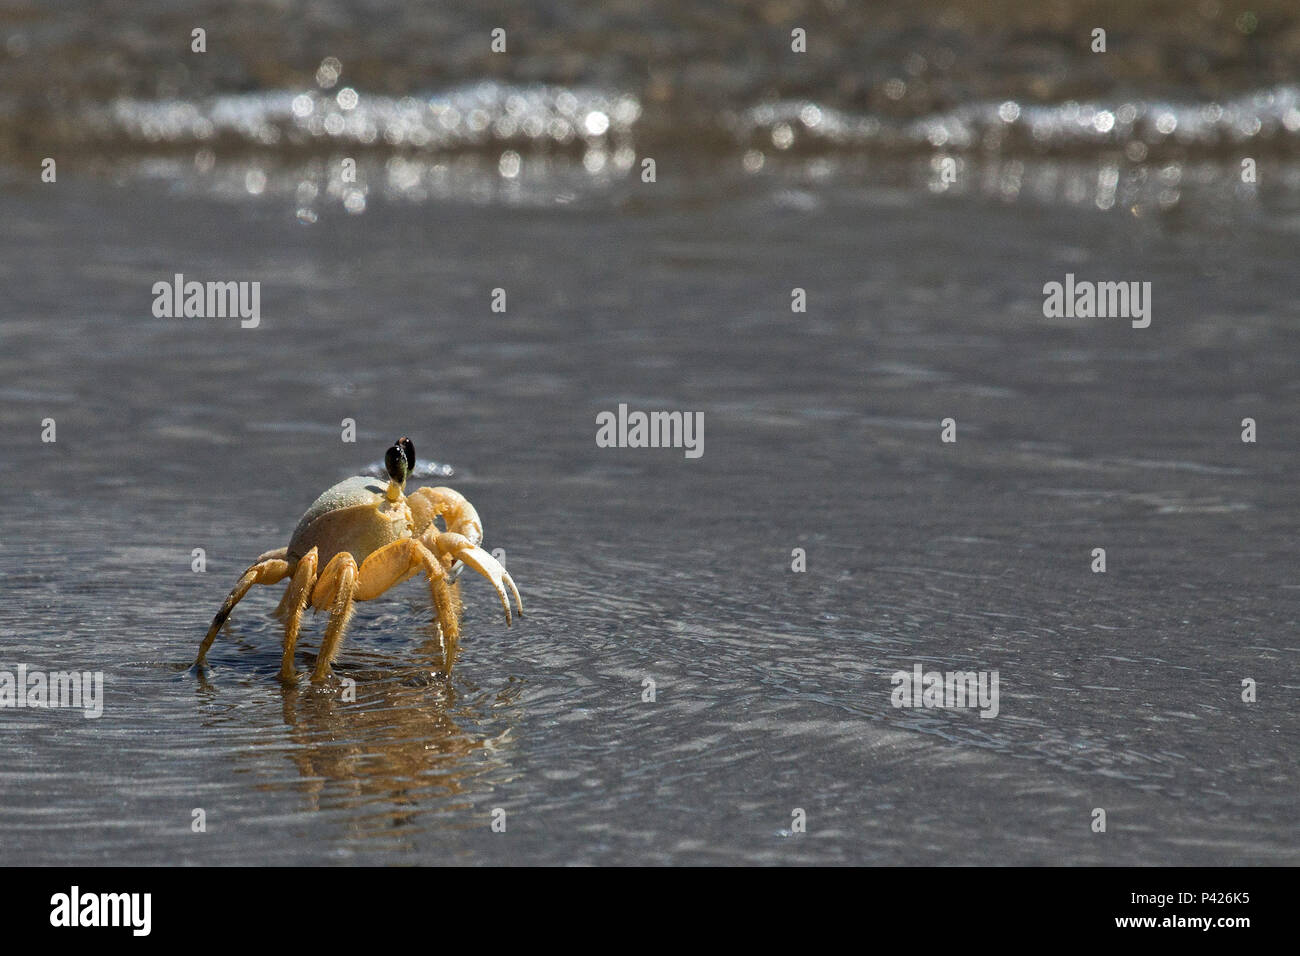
[0,0,1300,865]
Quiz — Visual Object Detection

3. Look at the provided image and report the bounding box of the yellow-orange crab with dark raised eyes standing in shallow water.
[195,437,524,684]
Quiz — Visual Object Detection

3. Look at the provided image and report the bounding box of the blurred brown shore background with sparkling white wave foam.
[0,0,1300,205]
